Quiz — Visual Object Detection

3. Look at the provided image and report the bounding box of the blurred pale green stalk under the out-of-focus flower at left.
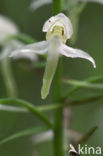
[1,57,17,98]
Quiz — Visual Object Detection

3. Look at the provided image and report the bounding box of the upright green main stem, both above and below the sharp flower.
[53,0,64,156]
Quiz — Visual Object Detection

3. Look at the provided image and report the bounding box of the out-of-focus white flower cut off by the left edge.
[0,15,37,61]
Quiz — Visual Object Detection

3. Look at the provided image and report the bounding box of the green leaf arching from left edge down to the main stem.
[0,98,53,127]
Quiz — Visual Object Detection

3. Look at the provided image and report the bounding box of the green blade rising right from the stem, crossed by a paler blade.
[63,76,103,99]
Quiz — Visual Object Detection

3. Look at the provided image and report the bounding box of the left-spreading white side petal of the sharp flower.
[10,41,48,58]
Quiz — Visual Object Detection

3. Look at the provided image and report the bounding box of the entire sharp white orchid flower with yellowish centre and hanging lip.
[11,13,96,99]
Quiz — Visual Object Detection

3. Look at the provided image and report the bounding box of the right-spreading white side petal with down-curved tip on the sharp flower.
[60,44,96,68]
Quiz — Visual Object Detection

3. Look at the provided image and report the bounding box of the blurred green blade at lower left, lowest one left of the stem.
[0,127,49,145]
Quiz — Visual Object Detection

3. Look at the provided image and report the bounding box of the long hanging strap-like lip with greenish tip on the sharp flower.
[41,36,61,99]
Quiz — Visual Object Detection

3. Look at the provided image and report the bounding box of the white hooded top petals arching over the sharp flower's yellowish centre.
[42,13,73,39]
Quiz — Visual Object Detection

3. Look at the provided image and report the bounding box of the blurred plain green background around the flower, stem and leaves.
[0,0,103,156]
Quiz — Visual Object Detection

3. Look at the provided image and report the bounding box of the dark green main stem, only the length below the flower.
[54,60,63,156]
